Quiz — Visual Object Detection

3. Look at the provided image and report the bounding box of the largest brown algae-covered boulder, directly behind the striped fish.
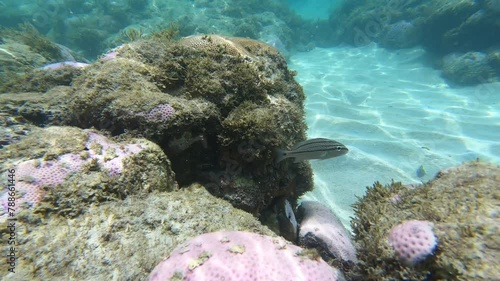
[59,35,312,215]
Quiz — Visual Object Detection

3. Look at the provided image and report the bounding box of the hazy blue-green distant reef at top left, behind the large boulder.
[0,0,312,59]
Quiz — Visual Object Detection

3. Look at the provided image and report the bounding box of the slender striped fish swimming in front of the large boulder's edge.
[275,138,349,163]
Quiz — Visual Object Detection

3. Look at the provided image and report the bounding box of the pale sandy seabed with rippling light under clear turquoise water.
[289,44,500,228]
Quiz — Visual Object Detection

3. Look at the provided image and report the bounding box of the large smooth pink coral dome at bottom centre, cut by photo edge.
[148,231,345,281]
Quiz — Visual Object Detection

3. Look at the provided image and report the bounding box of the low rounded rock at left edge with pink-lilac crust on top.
[0,127,177,220]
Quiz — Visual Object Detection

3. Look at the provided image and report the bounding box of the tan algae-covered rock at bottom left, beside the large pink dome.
[0,184,274,281]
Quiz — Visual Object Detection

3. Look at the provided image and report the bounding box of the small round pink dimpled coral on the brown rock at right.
[389,220,438,265]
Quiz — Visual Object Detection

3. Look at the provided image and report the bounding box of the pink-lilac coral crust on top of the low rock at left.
[0,132,142,218]
